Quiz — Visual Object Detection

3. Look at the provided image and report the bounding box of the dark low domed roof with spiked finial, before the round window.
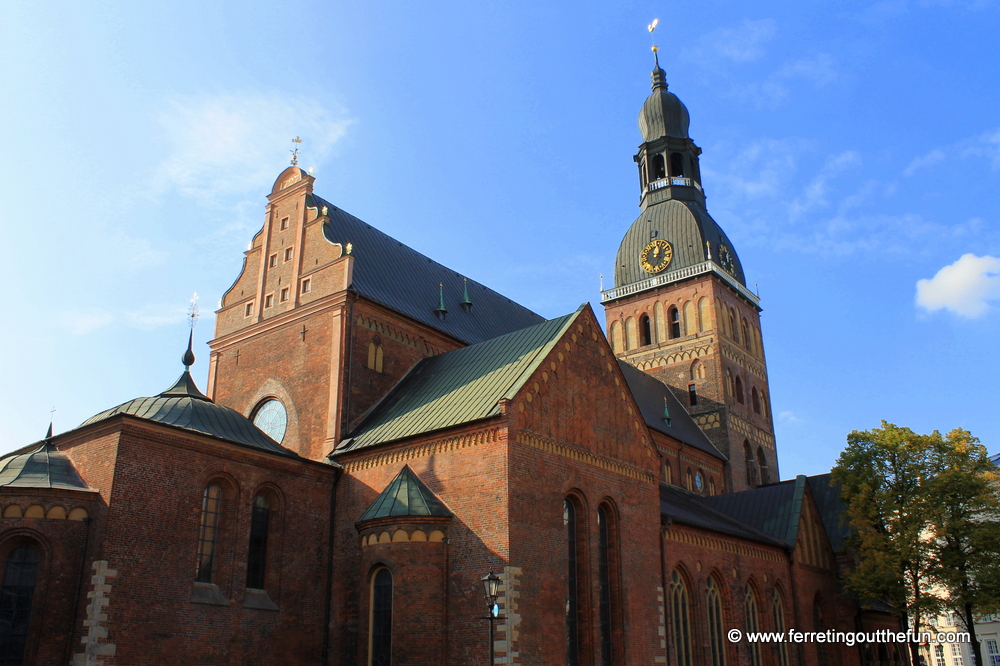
[81,370,297,457]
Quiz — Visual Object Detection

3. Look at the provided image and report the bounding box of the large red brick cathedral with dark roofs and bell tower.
[0,66,905,666]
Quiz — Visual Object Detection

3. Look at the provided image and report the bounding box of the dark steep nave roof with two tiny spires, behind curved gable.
[308,195,545,344]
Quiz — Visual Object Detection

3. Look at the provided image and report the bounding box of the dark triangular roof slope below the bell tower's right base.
[703,474,806,546]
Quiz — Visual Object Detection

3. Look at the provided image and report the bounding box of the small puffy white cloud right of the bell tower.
[917,253,1000,319]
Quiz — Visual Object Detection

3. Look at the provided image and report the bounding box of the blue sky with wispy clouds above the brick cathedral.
[0,0,1000,477]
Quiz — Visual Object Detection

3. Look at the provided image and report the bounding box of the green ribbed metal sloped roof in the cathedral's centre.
[336,306,584,453]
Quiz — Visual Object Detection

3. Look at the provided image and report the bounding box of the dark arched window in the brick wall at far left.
[0,545,39,666]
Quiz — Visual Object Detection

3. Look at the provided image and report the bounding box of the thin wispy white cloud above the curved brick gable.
[150,93,351,199]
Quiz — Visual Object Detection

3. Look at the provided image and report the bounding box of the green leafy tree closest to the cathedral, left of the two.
[833,421,942,664]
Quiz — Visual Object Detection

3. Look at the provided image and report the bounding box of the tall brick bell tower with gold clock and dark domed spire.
[601,63,780,490]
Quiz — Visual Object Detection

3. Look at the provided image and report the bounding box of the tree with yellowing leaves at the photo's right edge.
[929,429,1000,664]
